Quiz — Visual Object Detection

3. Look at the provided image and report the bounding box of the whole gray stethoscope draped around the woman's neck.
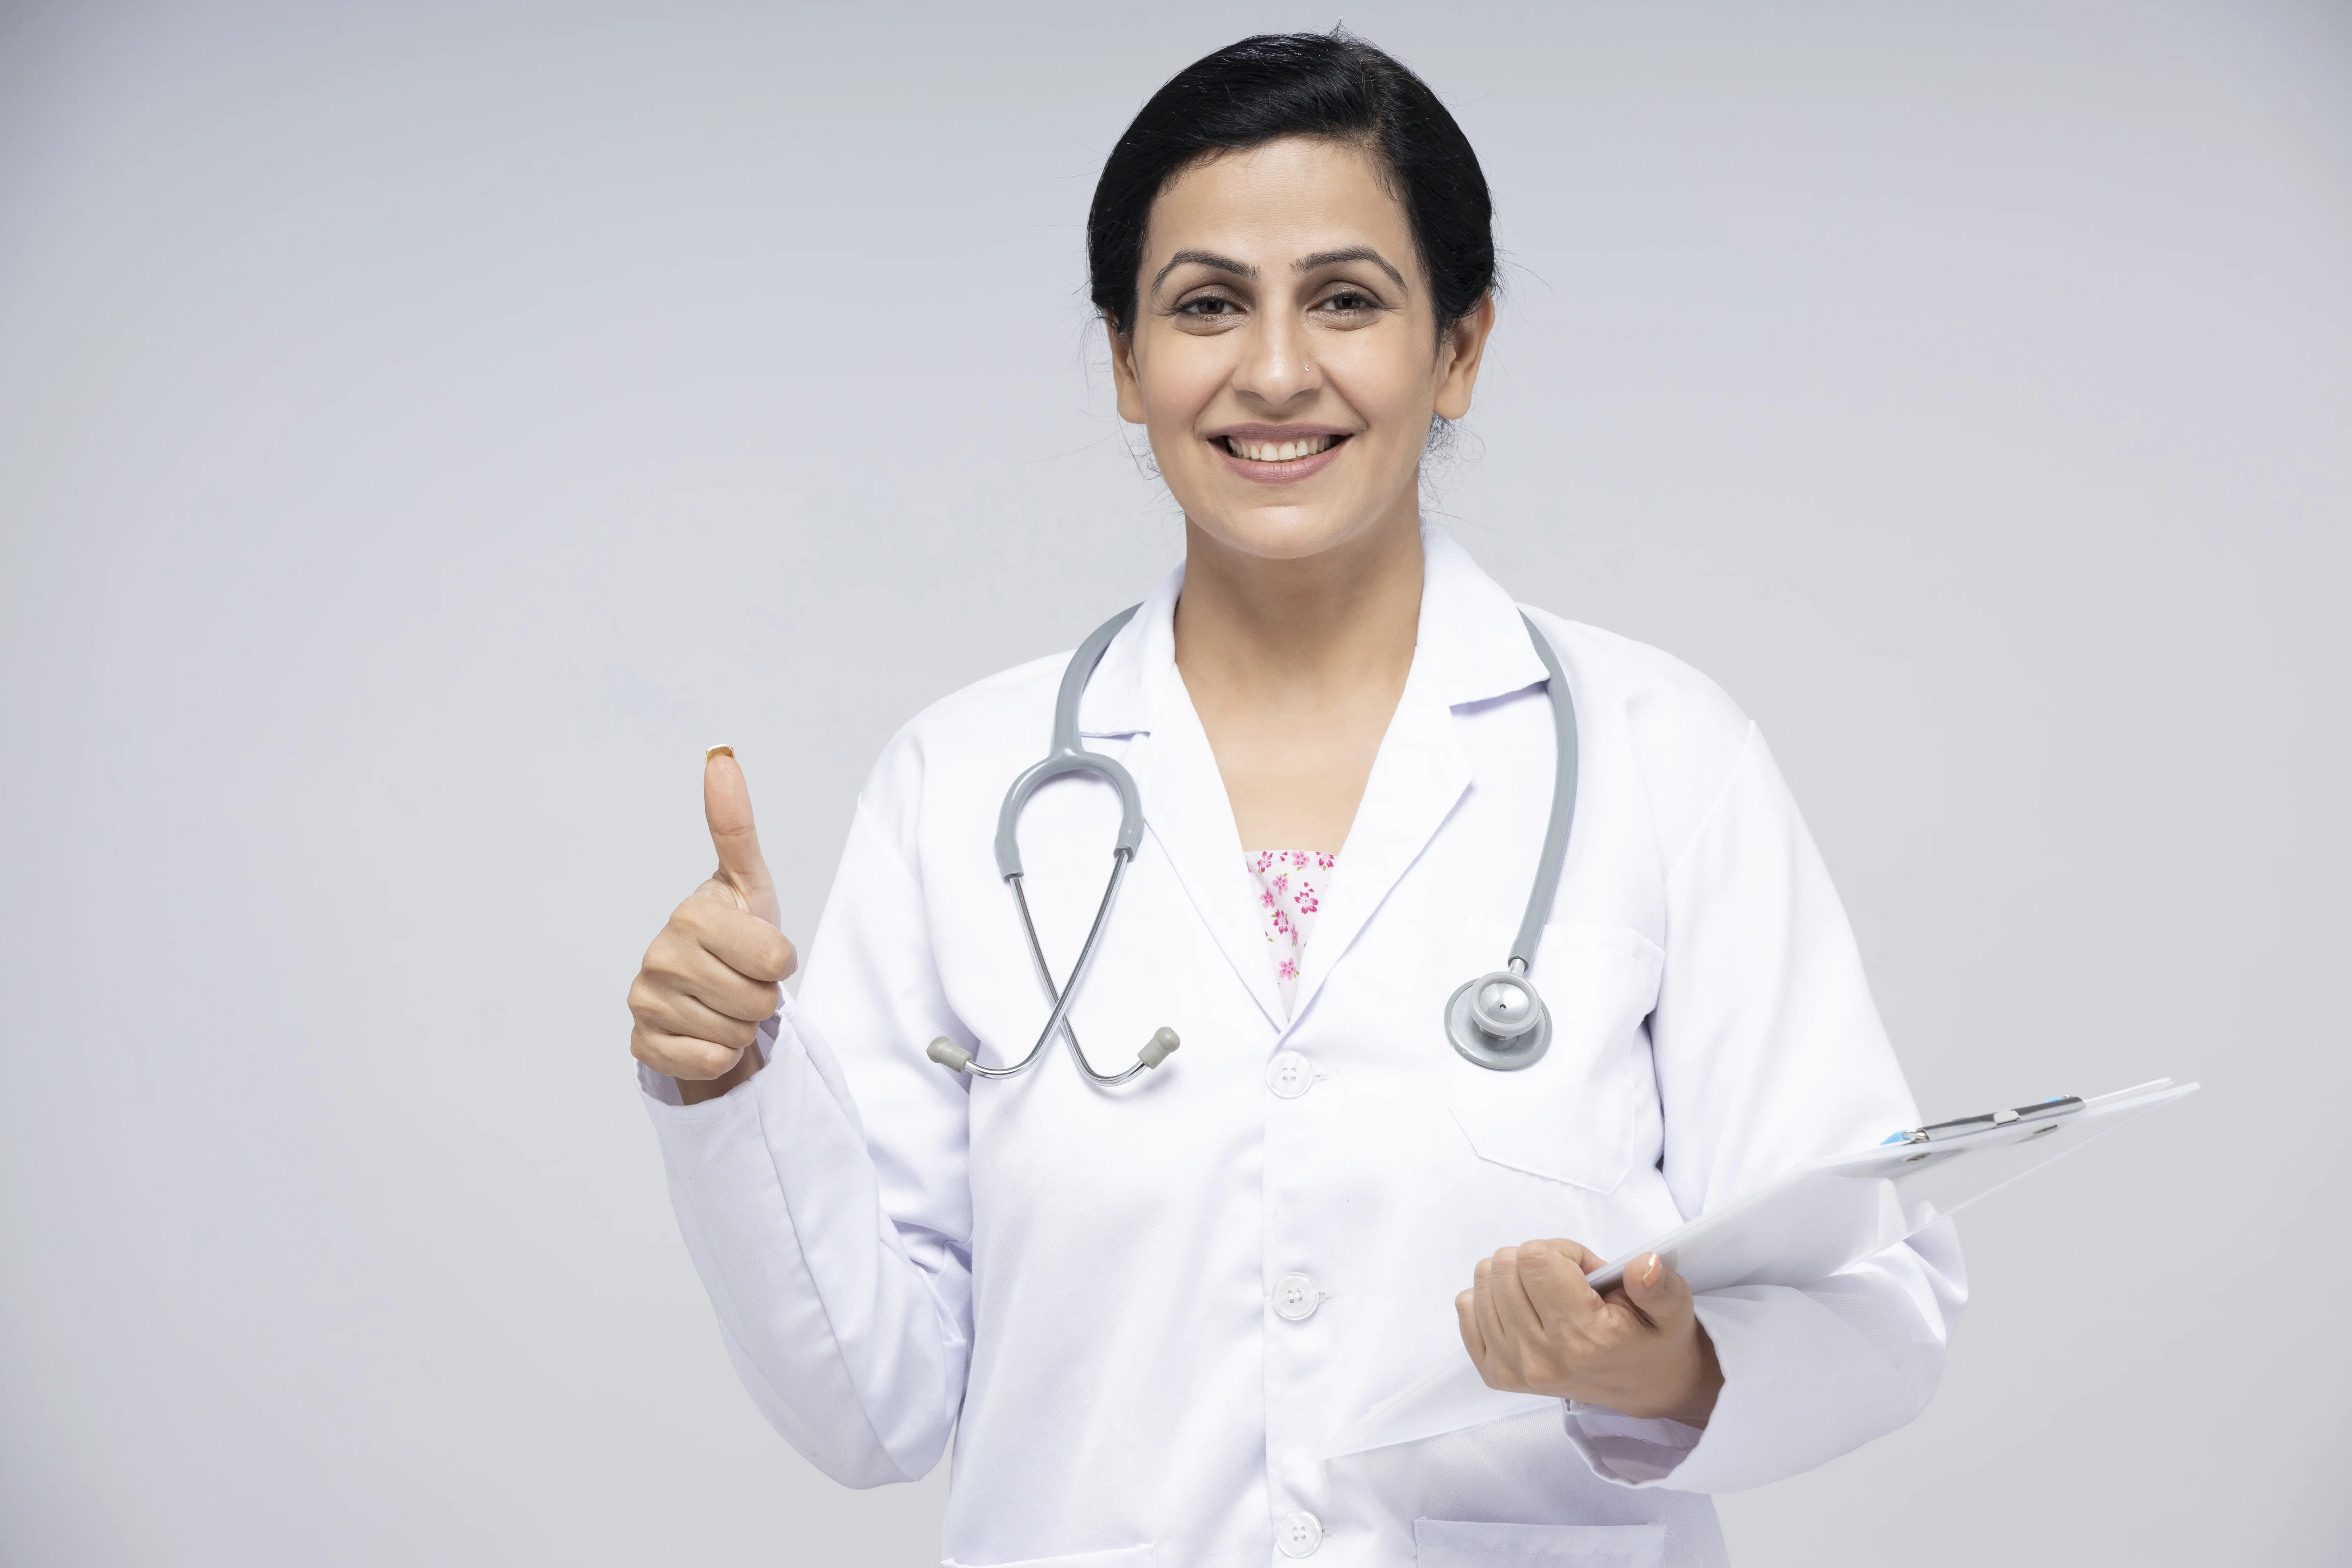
[927,604,1576,1088]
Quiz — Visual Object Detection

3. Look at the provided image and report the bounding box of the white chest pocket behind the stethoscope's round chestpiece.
[1451,922,1665,1192]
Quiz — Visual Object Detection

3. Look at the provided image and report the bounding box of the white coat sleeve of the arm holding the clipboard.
[1567,726,1966,1493]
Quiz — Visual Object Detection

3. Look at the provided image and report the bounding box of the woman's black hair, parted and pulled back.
[1087,28,1496,334]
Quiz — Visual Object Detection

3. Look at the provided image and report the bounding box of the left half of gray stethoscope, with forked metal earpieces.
[927,604,1178,1088]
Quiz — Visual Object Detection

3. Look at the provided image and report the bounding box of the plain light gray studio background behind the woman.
[0,0,2352,1568]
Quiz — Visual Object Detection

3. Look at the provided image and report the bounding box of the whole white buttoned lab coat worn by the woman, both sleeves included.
[642,529,1964,1568]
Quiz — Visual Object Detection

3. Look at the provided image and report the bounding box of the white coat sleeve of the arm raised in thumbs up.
[640,802,971,1486]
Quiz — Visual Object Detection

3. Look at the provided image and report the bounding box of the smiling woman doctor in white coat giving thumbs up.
[630,35,1964,1568]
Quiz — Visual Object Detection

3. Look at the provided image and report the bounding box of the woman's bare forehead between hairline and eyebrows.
[1143,136,1416,278]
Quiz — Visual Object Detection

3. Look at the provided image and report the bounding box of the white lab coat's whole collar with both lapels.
[1079,524,1543,1030]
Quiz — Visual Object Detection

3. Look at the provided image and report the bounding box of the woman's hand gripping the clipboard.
[1454,1241,1724,1427]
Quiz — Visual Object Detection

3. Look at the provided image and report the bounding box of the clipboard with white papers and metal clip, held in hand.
[1317,1079,2197,1460]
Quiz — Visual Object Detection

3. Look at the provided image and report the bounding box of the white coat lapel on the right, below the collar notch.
[1275,637,1470,1018]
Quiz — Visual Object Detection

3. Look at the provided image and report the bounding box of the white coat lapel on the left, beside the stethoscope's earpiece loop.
[1136,677,1282,1030]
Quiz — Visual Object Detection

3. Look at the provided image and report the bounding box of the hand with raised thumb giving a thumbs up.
[628,745,800,1105]
